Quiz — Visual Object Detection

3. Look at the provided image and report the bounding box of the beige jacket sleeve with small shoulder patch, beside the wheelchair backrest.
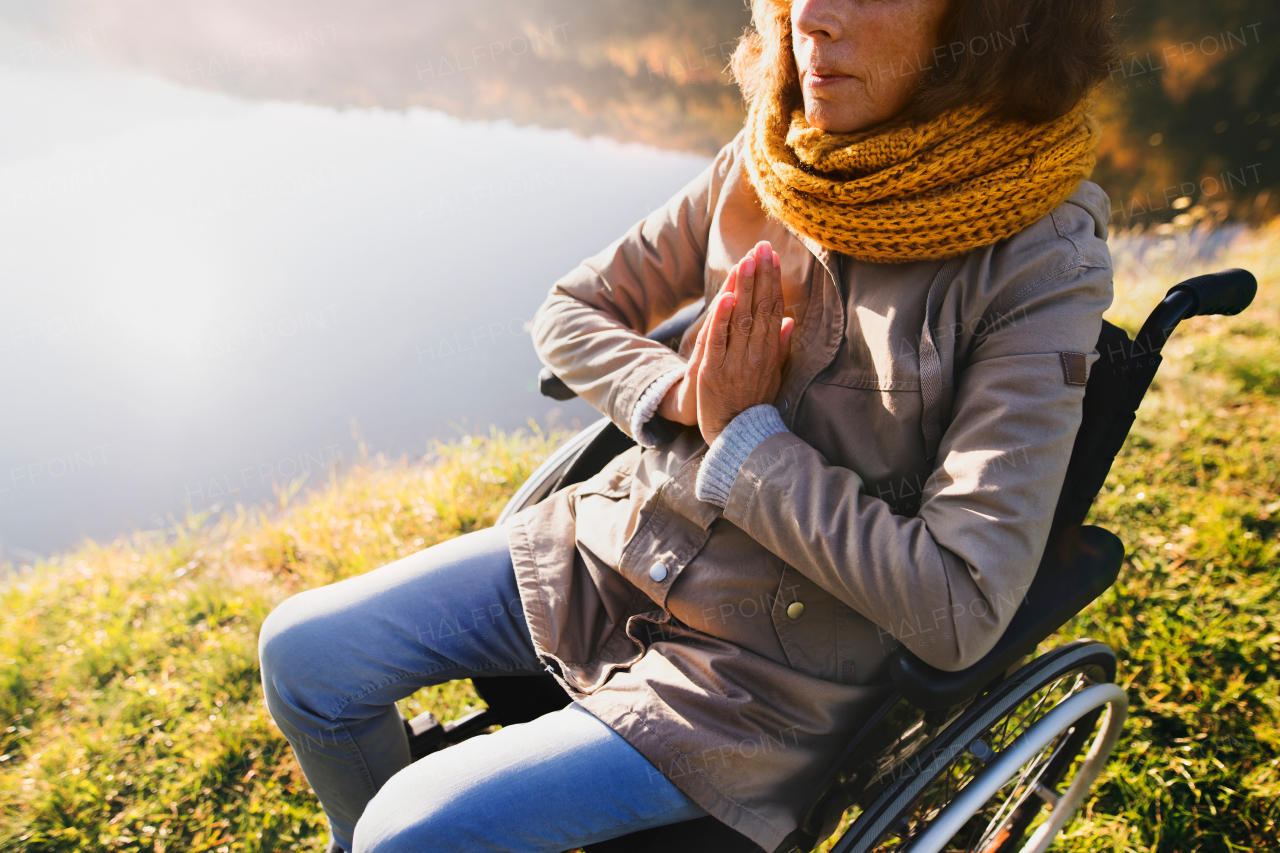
[713,266,1111,671]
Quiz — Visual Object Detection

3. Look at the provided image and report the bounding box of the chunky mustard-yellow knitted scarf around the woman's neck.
[746,96,1100,263]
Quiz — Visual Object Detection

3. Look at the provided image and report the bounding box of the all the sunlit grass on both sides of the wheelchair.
[0,216,1280,853]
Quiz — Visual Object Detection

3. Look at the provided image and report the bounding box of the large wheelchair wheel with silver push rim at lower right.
[832,642,1128,853]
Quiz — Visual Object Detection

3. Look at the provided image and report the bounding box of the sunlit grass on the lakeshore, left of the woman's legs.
[0,432,563,853]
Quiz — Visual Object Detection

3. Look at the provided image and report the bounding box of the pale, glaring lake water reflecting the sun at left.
[0,61,707,562]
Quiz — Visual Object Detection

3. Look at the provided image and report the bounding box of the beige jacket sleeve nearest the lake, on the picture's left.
[532,140,737,438]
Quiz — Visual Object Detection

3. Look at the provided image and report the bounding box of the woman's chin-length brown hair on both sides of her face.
[732,0,1119,123]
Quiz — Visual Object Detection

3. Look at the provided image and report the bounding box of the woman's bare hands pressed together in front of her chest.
[658,241,795,444]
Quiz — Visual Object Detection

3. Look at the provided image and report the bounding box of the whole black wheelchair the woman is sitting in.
[404,263,1257,853]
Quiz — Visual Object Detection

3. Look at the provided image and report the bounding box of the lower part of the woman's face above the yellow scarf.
[791,0,947,133]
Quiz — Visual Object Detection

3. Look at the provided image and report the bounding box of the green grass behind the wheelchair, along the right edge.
[1039,222,1280,852]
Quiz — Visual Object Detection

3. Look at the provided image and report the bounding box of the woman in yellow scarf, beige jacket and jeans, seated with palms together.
[261,0,1112,853]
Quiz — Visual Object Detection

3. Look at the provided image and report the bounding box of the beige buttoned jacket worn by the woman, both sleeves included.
[511,134,1111,850]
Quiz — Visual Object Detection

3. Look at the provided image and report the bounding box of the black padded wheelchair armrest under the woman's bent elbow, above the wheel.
[890,526,1124,711]
